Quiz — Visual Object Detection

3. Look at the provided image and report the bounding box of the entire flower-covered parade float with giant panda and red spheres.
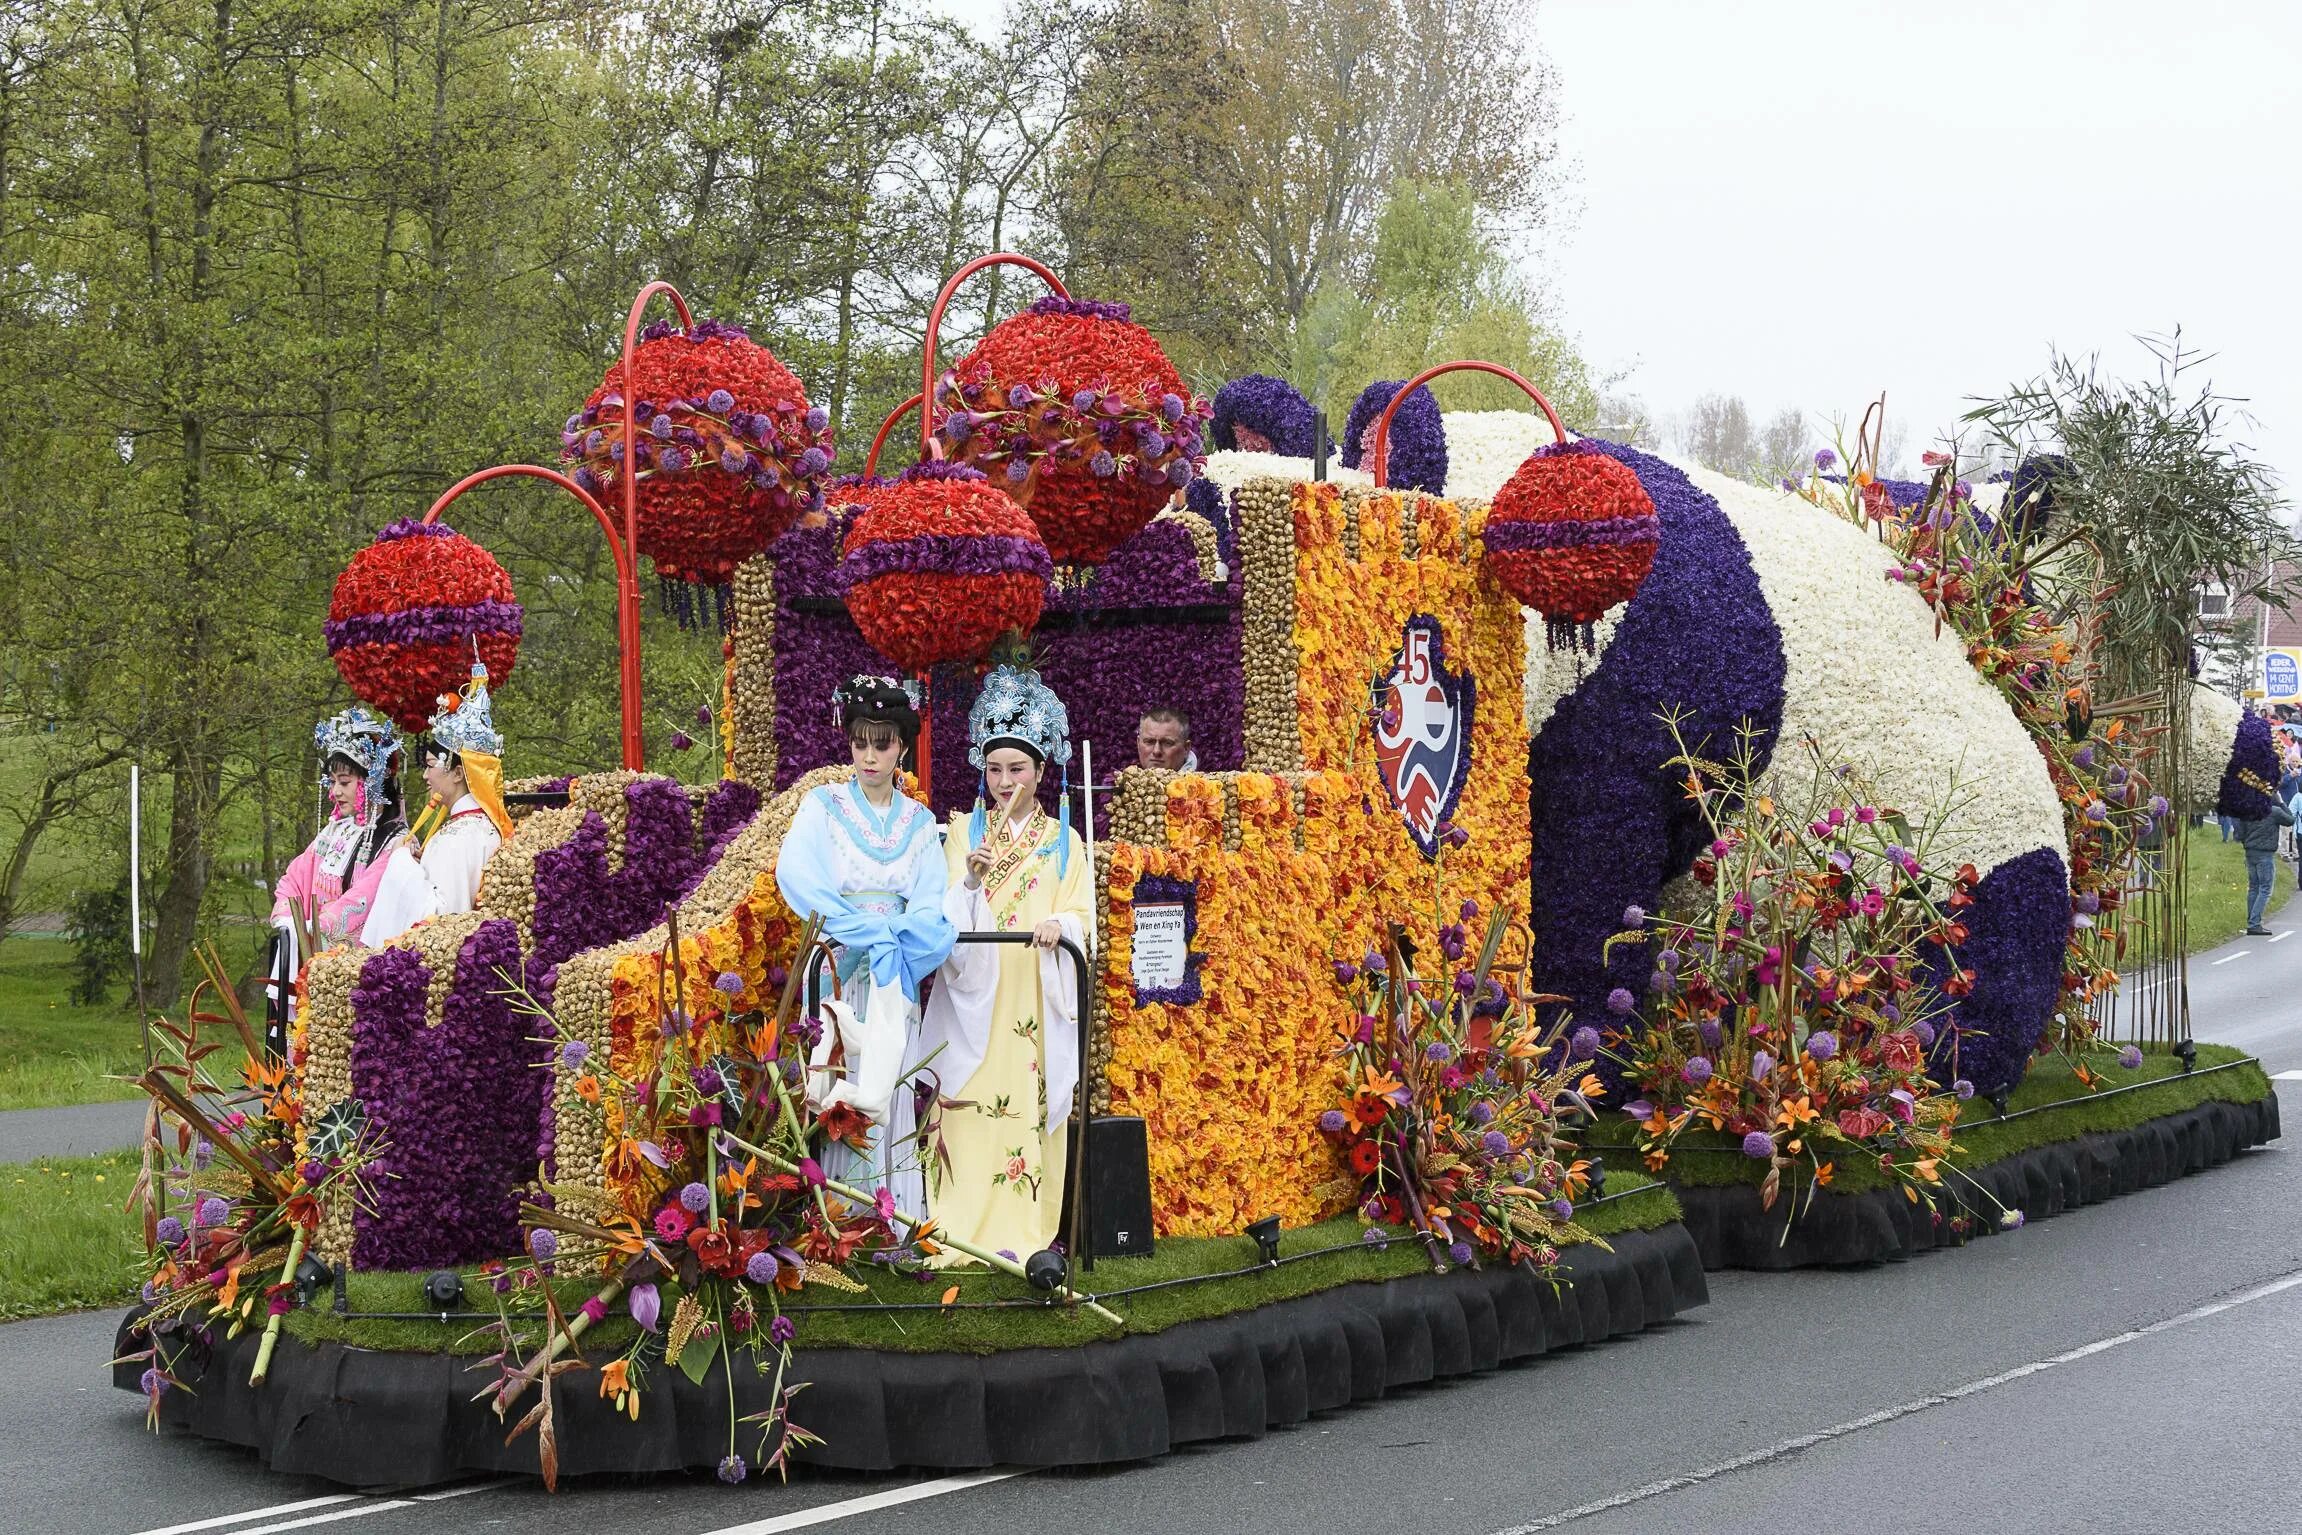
[115,258,2277,1484]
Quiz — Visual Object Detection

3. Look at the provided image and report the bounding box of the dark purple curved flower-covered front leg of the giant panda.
[1526,440,1786,1049]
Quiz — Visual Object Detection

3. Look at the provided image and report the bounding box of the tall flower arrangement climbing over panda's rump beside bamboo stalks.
[1786,437,2175,1063]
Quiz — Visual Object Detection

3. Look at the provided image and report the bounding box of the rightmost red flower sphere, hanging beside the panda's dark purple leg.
[1485,442,1662,649]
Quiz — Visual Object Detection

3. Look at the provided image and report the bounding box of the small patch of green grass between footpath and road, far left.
[0,1151,143,1321]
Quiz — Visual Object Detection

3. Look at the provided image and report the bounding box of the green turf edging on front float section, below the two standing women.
[285,1174,1678,1358]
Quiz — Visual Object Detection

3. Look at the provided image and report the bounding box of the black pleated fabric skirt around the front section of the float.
[113,1224,1708,1487]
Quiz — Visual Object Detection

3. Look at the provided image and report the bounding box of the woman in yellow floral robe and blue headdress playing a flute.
[921,667,1096,1261]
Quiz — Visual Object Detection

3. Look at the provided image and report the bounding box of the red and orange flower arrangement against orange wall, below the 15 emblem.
[1319,902,1604,1277]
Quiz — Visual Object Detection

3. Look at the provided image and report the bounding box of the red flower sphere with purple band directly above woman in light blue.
[833,463,1054,672]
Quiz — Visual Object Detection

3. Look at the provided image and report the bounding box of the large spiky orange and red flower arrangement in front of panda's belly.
[1602,720,2034,1231]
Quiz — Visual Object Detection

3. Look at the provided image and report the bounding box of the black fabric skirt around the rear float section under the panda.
[1671,1093,2279,1270]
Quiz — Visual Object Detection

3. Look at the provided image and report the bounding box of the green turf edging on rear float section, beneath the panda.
[1586,1045,2272,1194]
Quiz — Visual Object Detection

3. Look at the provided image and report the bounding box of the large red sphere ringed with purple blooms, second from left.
[559,320,831,587]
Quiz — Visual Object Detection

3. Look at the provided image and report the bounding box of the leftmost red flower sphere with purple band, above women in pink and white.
[322,520,520,730]
